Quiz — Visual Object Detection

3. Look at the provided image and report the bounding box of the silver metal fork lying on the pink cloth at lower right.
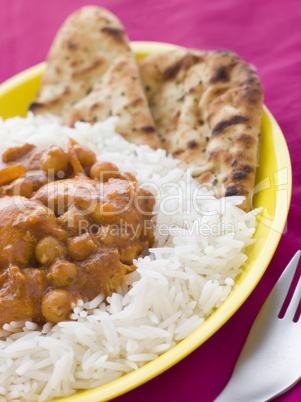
[215,250,301,402]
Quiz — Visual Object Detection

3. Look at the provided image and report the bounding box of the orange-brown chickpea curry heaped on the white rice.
[0,138,155,326]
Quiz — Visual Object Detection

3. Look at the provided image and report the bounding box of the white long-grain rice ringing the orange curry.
[0,114,256,402]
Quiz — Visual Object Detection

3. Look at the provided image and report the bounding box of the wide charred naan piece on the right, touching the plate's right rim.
[140,48,263,211]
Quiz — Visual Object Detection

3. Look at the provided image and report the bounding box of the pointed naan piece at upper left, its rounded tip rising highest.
[30,6,160,149]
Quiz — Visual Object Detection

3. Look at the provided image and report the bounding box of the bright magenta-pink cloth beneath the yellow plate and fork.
[0,0,301,402]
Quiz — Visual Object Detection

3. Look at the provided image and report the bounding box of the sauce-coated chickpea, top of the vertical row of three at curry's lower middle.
[35,236,65,265]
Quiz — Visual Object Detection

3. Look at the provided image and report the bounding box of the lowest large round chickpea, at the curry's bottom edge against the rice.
[41,289,77,323]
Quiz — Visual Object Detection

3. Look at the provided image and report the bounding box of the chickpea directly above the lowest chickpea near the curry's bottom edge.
[47,260,77,286]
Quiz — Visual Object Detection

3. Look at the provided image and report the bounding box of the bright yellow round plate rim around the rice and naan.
[0,42,292,402]
